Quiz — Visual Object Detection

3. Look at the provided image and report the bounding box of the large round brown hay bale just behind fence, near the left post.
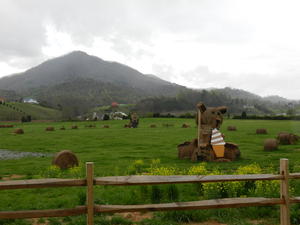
[52,150,79,169]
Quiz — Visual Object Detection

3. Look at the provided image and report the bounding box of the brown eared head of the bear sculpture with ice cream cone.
[196,103,227,129]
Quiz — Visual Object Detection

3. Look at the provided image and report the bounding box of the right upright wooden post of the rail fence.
[280,159,290,225]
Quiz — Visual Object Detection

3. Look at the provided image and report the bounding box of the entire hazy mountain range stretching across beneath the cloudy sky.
[0,51,299,118]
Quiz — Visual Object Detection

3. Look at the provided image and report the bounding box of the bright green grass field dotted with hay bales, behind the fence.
[0,118,300,225]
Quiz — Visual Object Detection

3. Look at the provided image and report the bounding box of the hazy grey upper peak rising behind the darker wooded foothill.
[0,51,184,96]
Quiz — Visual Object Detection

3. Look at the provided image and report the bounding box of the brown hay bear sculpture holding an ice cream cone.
[178,103,240,162]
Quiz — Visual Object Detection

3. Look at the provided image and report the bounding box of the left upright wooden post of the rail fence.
[86,162,94,225]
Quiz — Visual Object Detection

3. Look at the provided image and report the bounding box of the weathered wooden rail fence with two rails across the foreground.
[0,159,300,225]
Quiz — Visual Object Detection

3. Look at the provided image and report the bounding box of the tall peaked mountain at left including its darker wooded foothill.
[0,51,186,115]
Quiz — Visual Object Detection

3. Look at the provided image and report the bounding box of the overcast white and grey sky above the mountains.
[0,0,300,99]
